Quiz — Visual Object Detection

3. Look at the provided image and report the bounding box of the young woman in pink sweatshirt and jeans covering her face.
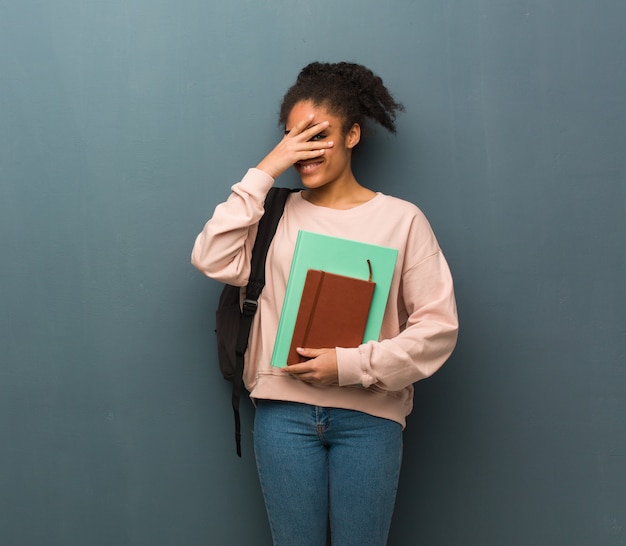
[192,63,457,546]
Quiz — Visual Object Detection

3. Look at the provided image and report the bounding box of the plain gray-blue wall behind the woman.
[0,0,626,546]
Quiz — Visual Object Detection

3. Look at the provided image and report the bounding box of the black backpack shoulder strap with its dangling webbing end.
[232,187,295,457]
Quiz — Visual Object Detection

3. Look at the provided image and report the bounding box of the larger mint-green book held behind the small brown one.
[272,230,398,368]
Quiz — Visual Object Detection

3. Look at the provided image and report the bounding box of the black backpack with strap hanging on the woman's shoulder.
[215,188,296,457]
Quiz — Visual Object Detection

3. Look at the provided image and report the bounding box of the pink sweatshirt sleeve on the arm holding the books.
[337,216,458,391]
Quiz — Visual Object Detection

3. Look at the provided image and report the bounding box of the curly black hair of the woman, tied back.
[279,62,404,133]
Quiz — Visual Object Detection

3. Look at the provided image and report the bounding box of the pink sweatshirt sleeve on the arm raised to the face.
[191,169,274,286]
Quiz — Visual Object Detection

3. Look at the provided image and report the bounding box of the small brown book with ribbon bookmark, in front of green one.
[287,260,376,364]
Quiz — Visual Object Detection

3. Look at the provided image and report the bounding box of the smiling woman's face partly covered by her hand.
[285,101,361,189]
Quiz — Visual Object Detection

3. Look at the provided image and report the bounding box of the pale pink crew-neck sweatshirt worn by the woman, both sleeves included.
[191,169,458,427]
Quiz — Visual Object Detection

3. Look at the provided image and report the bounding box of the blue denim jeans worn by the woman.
[254,400,402,546]
